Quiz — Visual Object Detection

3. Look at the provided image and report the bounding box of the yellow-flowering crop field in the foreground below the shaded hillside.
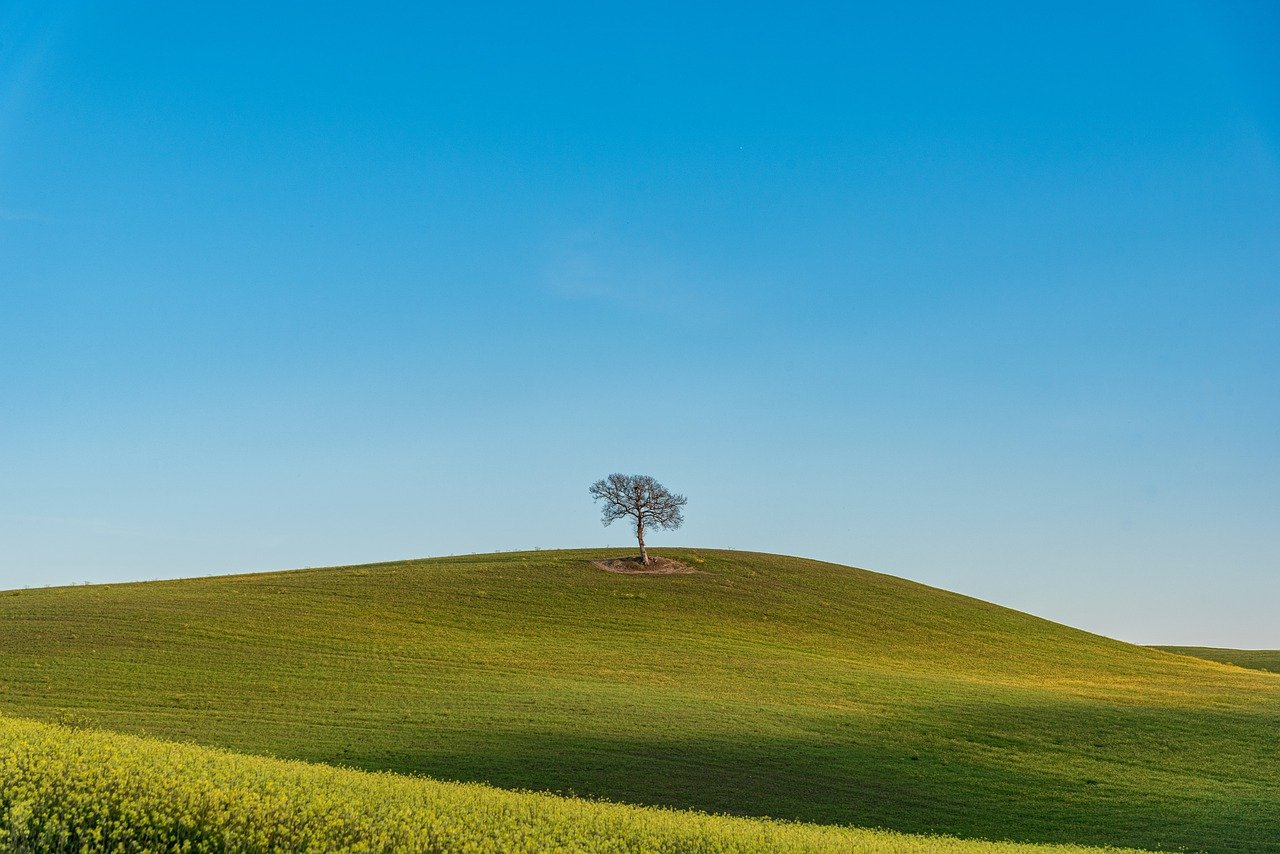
[0,718,1146,854]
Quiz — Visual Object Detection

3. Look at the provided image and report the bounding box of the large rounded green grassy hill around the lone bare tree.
[0,551,1280,851]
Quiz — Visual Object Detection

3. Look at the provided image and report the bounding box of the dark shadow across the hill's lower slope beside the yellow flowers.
[322,708,1280,853]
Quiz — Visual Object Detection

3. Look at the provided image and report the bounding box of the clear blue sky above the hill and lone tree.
[0,0,1280,648]
